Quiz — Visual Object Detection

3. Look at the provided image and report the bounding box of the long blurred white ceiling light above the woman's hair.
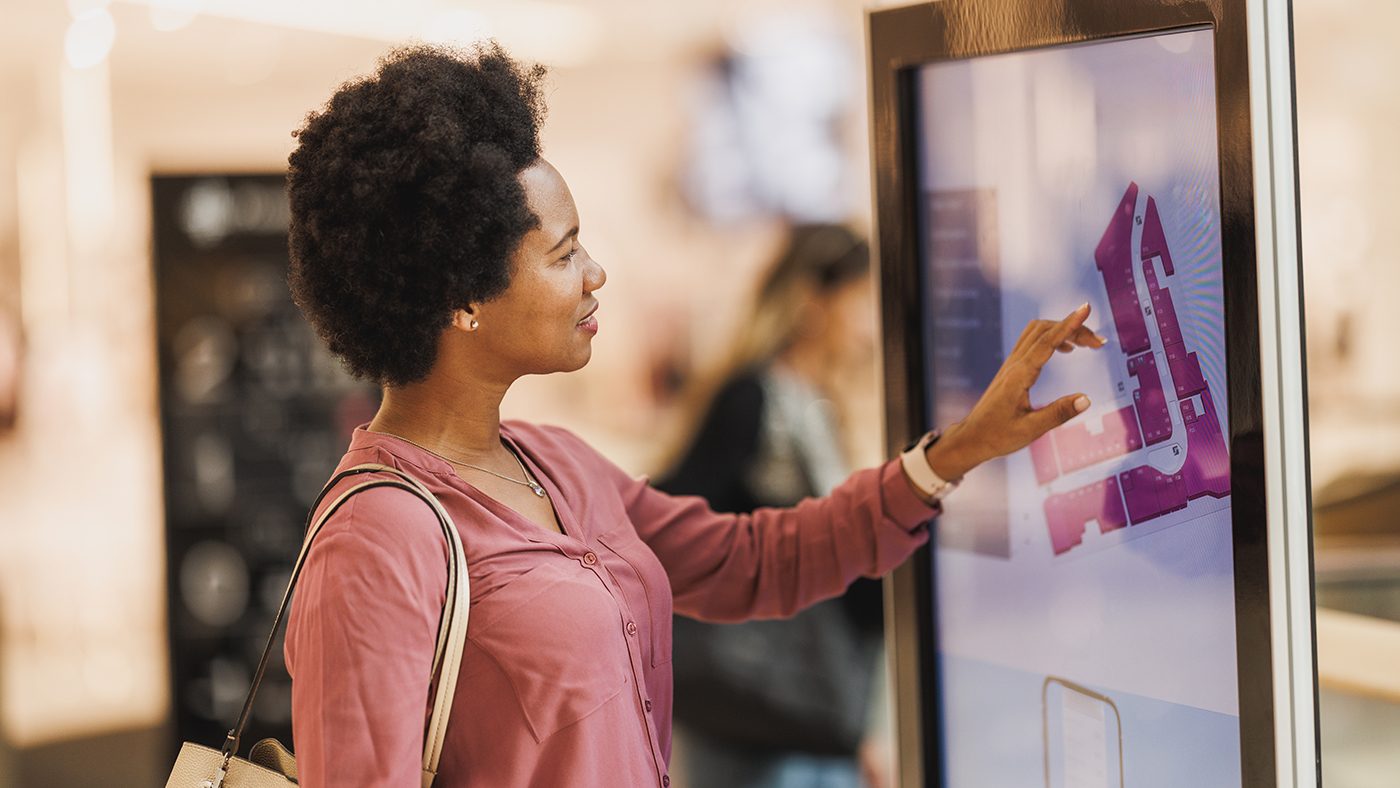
[113,0,606,67]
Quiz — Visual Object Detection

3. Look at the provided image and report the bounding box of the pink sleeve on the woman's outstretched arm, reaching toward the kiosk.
[588,431,939,621]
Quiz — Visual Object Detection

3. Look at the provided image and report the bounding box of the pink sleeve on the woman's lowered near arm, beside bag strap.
[286,488,448,788]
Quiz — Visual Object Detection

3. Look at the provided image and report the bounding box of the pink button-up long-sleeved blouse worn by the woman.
[286,421,938,788]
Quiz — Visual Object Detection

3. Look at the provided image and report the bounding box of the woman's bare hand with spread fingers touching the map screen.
[927,304,1107,480]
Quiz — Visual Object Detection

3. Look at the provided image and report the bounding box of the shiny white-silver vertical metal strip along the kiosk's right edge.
[1247,0,1320,788]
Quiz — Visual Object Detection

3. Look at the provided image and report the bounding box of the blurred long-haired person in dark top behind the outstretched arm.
[657,224,888,788]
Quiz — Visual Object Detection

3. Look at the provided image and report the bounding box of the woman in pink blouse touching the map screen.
[286,45,1102,788]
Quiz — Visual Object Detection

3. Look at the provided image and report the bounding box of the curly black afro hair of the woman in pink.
[287,42,545,385]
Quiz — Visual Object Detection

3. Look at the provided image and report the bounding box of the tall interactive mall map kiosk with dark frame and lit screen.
[869,0,1317,788]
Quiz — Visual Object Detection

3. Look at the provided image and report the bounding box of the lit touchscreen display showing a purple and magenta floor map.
[914,29,1240,788]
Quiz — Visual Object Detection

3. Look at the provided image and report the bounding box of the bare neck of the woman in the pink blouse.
[370,375,510,462]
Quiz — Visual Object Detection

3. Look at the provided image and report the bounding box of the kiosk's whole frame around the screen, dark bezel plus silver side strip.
[868,0,1320,788]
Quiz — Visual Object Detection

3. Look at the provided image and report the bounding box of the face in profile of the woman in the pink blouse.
[473,158,608,375]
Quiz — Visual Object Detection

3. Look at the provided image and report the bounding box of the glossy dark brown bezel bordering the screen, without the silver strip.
[868,0,1277,787]
